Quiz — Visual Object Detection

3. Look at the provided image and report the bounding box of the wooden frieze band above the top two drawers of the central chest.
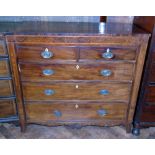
[6,33,144,47]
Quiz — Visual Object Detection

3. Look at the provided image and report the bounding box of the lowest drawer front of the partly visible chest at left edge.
[0,100,16,117]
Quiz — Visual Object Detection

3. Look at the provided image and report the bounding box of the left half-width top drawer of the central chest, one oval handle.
[17,45,76,62]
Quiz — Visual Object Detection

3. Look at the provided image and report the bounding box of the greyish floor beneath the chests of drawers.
[0,123,155,139]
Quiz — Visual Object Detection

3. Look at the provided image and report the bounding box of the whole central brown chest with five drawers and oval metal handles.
[0,22,149,132]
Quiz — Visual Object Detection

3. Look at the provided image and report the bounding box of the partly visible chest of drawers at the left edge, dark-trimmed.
[0,35,17,122]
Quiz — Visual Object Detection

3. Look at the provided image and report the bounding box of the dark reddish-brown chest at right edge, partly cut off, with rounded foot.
[133,16,155,135]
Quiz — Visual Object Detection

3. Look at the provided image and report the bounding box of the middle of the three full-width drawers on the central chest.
[23,82,131,102]
